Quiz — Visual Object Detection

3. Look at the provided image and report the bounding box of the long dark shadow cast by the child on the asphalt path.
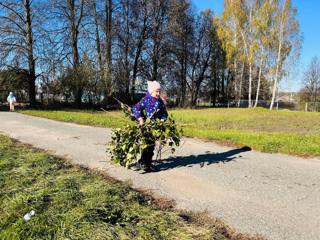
[156,146,251,171]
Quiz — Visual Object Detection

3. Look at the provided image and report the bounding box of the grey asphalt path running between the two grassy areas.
[0,112,320,240]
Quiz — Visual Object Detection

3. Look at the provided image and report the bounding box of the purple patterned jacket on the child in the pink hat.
[132,93,168,121]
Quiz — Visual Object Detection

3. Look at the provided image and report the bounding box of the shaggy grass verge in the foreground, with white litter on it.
[0,135,260,240]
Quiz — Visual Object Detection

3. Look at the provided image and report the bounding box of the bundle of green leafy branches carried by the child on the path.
[108,103,182,168]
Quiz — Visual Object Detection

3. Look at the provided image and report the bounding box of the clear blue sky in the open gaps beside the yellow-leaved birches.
[193,0,320,91]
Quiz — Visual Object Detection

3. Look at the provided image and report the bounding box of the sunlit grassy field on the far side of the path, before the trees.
[22,108,320,156]
